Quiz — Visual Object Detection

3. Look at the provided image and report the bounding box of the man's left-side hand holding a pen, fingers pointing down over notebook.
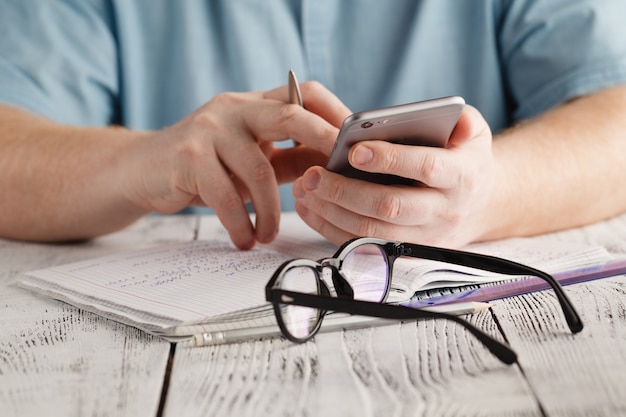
[118,82,348,249]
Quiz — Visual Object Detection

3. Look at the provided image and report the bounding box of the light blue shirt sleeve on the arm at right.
[499,0,626,120]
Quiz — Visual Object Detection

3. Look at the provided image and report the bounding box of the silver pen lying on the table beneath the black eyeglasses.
[191,301,490,347]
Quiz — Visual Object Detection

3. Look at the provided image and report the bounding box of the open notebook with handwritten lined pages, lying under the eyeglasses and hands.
[20,214,610,337]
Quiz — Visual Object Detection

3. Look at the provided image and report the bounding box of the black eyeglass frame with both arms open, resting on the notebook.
[265,238,583,364]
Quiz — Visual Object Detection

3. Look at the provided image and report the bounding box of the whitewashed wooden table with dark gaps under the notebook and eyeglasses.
[0,216,626,417]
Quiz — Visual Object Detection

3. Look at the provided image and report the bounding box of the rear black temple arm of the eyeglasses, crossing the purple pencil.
[397,243,584,333]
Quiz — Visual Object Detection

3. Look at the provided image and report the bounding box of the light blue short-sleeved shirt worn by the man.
[0,0,626,209]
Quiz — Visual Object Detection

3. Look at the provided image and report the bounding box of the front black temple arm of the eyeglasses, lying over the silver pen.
[272,290,517,365]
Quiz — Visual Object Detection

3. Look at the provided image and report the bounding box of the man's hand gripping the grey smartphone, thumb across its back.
[293,106,494,246]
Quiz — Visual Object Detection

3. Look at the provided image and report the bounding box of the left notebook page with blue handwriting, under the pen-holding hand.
[25,241,288,322]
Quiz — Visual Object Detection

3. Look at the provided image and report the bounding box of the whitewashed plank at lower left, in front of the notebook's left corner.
[0,288,169,416]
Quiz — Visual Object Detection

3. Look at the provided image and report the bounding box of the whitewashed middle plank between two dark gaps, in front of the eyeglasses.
[165,312,540,416]
